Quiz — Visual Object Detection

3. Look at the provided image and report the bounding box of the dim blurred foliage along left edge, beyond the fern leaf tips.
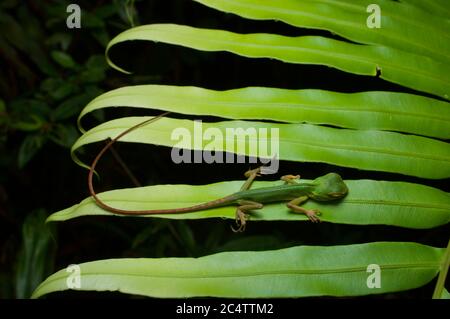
[0,0,138,298]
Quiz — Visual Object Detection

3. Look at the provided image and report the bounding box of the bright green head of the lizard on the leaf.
[309,173,348,201]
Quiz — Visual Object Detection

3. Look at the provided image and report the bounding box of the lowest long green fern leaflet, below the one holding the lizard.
[33,242,443,298]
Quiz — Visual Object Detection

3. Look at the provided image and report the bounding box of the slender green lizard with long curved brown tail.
[88,112,348,231]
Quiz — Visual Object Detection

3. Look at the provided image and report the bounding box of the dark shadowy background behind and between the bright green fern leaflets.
[0,0,449,298]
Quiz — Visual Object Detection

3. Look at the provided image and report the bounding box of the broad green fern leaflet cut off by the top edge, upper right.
[195,0,450,63]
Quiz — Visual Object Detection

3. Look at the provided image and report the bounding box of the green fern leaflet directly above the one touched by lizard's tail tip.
[79,85,450,139]
